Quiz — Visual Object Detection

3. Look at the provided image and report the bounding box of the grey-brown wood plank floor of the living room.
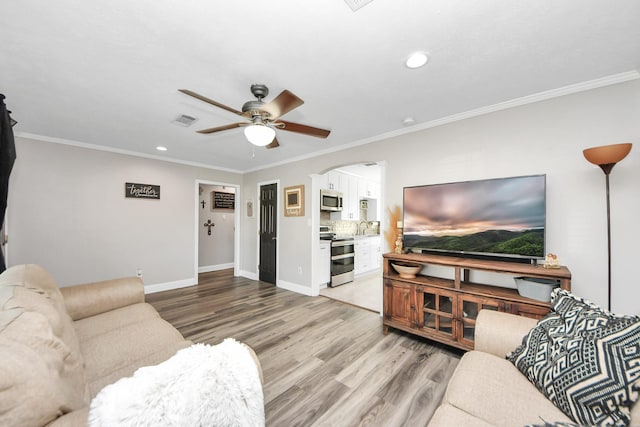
[147,270,460,427]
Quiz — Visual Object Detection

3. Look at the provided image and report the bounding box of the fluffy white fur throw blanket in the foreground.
[89,338,265,427]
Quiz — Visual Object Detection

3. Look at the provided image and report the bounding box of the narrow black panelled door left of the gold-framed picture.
[260,184,278,285]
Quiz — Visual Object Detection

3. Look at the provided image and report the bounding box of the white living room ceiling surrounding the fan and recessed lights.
[0,0,640,171]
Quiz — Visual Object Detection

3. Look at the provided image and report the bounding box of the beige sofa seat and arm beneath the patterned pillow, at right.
[429,310,640,427]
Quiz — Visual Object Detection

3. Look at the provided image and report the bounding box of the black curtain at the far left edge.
[0,93,16,273]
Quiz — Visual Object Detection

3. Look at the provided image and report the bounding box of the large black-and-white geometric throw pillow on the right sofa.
[507,288,640,426]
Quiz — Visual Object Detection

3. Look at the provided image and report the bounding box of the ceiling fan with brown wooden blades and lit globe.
[178,84,331,148]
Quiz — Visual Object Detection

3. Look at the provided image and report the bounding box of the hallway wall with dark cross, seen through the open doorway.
[198,184,236,272]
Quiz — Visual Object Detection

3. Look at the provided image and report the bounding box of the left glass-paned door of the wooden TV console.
[419,289,456,339]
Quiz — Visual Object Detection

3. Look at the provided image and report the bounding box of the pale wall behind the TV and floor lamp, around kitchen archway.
[241,80,640,313]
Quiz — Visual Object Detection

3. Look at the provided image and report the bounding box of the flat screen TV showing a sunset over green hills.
[403,175,546,262]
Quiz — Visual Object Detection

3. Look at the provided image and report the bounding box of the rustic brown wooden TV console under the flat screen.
[382,253,571,350]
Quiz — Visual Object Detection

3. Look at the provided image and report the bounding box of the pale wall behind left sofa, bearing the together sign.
[7,138,241,288]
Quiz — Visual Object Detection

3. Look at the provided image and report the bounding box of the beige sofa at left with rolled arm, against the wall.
[0,265,259,427]
